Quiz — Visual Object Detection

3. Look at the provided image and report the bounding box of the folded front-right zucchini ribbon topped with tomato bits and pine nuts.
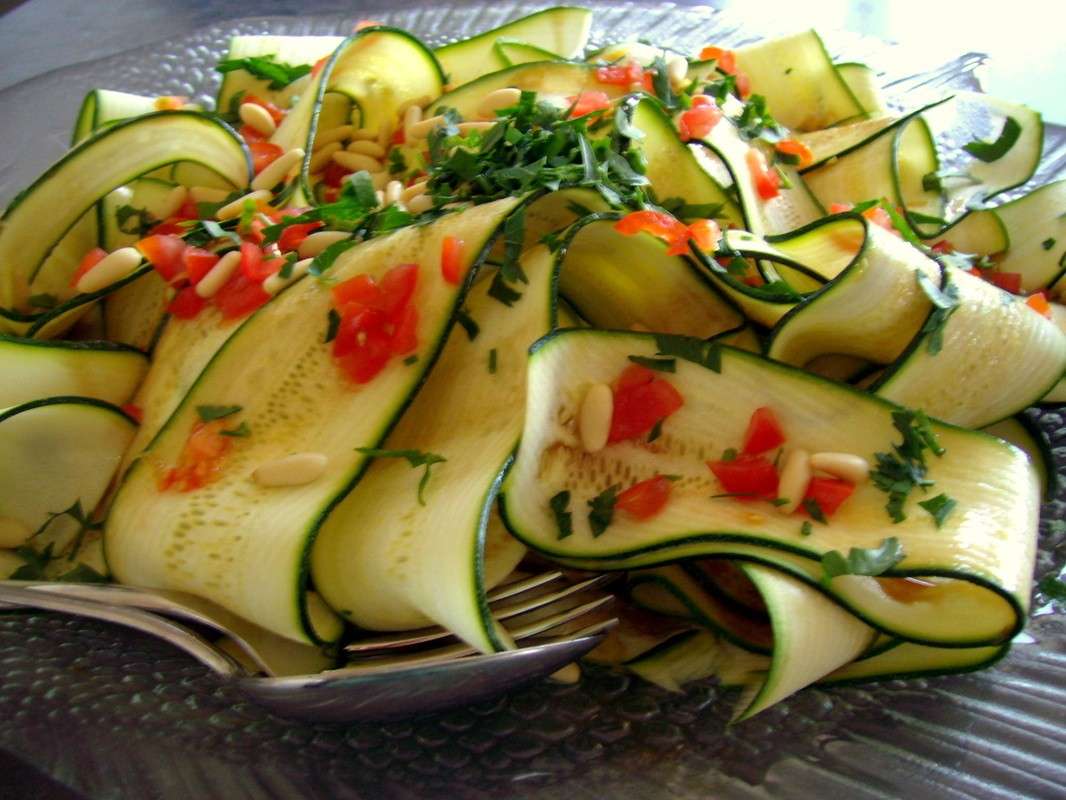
[501,331,1039,646]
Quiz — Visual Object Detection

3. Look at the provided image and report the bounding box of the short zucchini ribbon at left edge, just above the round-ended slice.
[0,336,148,409]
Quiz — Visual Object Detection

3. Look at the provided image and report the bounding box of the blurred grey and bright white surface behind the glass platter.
[0,0,1066,124]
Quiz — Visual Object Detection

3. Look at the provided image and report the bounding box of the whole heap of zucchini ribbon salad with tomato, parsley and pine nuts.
[0,7,1066,718]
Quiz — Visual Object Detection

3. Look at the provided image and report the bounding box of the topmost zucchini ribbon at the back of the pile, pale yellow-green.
[434,5,593,86]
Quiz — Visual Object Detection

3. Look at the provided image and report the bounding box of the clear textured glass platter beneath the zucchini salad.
[0,3,1066,800]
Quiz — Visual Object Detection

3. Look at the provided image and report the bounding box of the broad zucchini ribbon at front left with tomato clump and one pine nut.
[106,198,519,642]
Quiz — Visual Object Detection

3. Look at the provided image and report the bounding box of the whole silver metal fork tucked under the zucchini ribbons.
[0,573,616,721]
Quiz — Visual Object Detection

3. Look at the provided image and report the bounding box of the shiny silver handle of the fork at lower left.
[0,582,246,677]
